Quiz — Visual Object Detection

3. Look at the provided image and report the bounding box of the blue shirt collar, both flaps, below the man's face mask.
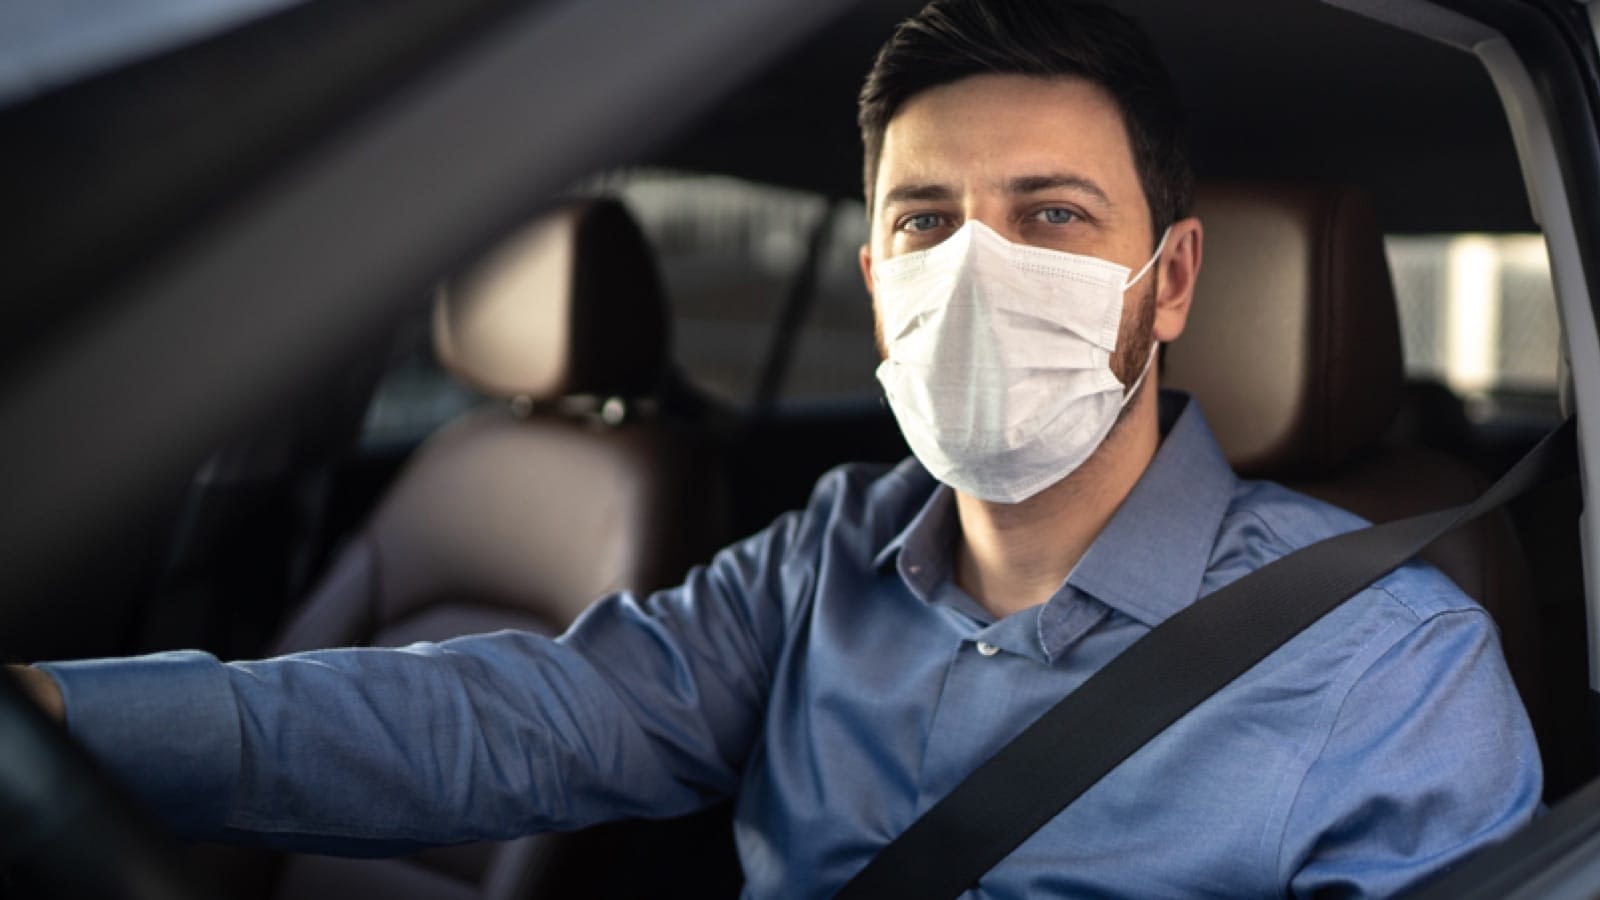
[874,391,1237,628]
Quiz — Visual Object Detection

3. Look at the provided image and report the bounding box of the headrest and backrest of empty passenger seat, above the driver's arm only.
[274,200,720,652]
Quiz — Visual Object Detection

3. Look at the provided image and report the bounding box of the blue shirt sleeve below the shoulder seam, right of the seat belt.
[1280,595,1542,897]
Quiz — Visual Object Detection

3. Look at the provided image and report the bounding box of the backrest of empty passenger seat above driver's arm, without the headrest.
[274,407,718,652]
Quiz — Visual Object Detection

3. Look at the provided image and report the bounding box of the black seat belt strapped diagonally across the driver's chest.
[837,420,1578,900]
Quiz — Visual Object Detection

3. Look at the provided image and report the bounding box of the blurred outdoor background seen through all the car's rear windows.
[353,168,1558,440]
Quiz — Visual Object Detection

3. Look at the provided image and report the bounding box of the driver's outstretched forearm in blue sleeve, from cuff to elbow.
[40,633,736,854]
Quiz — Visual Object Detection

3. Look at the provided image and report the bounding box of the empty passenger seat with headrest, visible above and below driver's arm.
[201,200,738,900]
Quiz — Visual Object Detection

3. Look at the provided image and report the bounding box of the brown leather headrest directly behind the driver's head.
[1162,183,1405,477]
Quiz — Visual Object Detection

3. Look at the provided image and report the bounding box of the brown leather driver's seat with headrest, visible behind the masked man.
[1162,183,1544,736]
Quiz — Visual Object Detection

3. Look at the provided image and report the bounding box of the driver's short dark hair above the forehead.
[858,0,1194,234]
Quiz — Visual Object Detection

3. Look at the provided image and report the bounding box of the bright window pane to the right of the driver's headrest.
[1387,234,1560,399]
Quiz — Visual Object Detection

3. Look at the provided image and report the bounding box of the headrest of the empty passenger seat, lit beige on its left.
[434,199,669,400]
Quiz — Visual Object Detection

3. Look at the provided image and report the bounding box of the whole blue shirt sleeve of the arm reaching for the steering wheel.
[42,506,803,854]
